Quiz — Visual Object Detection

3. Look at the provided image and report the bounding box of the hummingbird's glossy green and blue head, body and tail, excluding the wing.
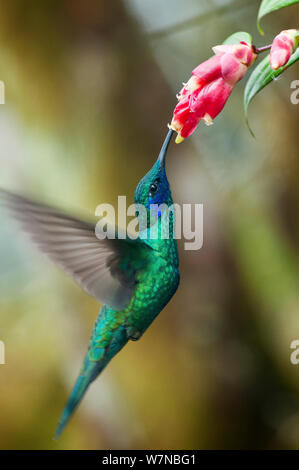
[56,131,179,436]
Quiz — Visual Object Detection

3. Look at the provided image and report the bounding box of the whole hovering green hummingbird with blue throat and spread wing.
[0,130,180,439]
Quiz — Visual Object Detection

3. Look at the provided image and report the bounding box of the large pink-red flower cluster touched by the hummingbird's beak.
[169,42,256,143]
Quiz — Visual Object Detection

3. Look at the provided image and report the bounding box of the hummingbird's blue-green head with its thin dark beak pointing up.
[134,130,173,210]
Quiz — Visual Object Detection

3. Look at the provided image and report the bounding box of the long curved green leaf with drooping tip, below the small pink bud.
[244,48,299,136]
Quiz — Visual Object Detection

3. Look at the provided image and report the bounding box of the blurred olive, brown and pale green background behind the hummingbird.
[0,0,299,449]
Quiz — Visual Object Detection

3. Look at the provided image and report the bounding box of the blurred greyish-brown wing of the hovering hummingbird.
[0,189,150,310]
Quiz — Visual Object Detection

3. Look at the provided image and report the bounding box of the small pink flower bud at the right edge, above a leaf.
[270,29,299,70]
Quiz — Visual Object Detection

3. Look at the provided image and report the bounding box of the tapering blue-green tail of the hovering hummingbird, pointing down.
[54,306,128,439]
